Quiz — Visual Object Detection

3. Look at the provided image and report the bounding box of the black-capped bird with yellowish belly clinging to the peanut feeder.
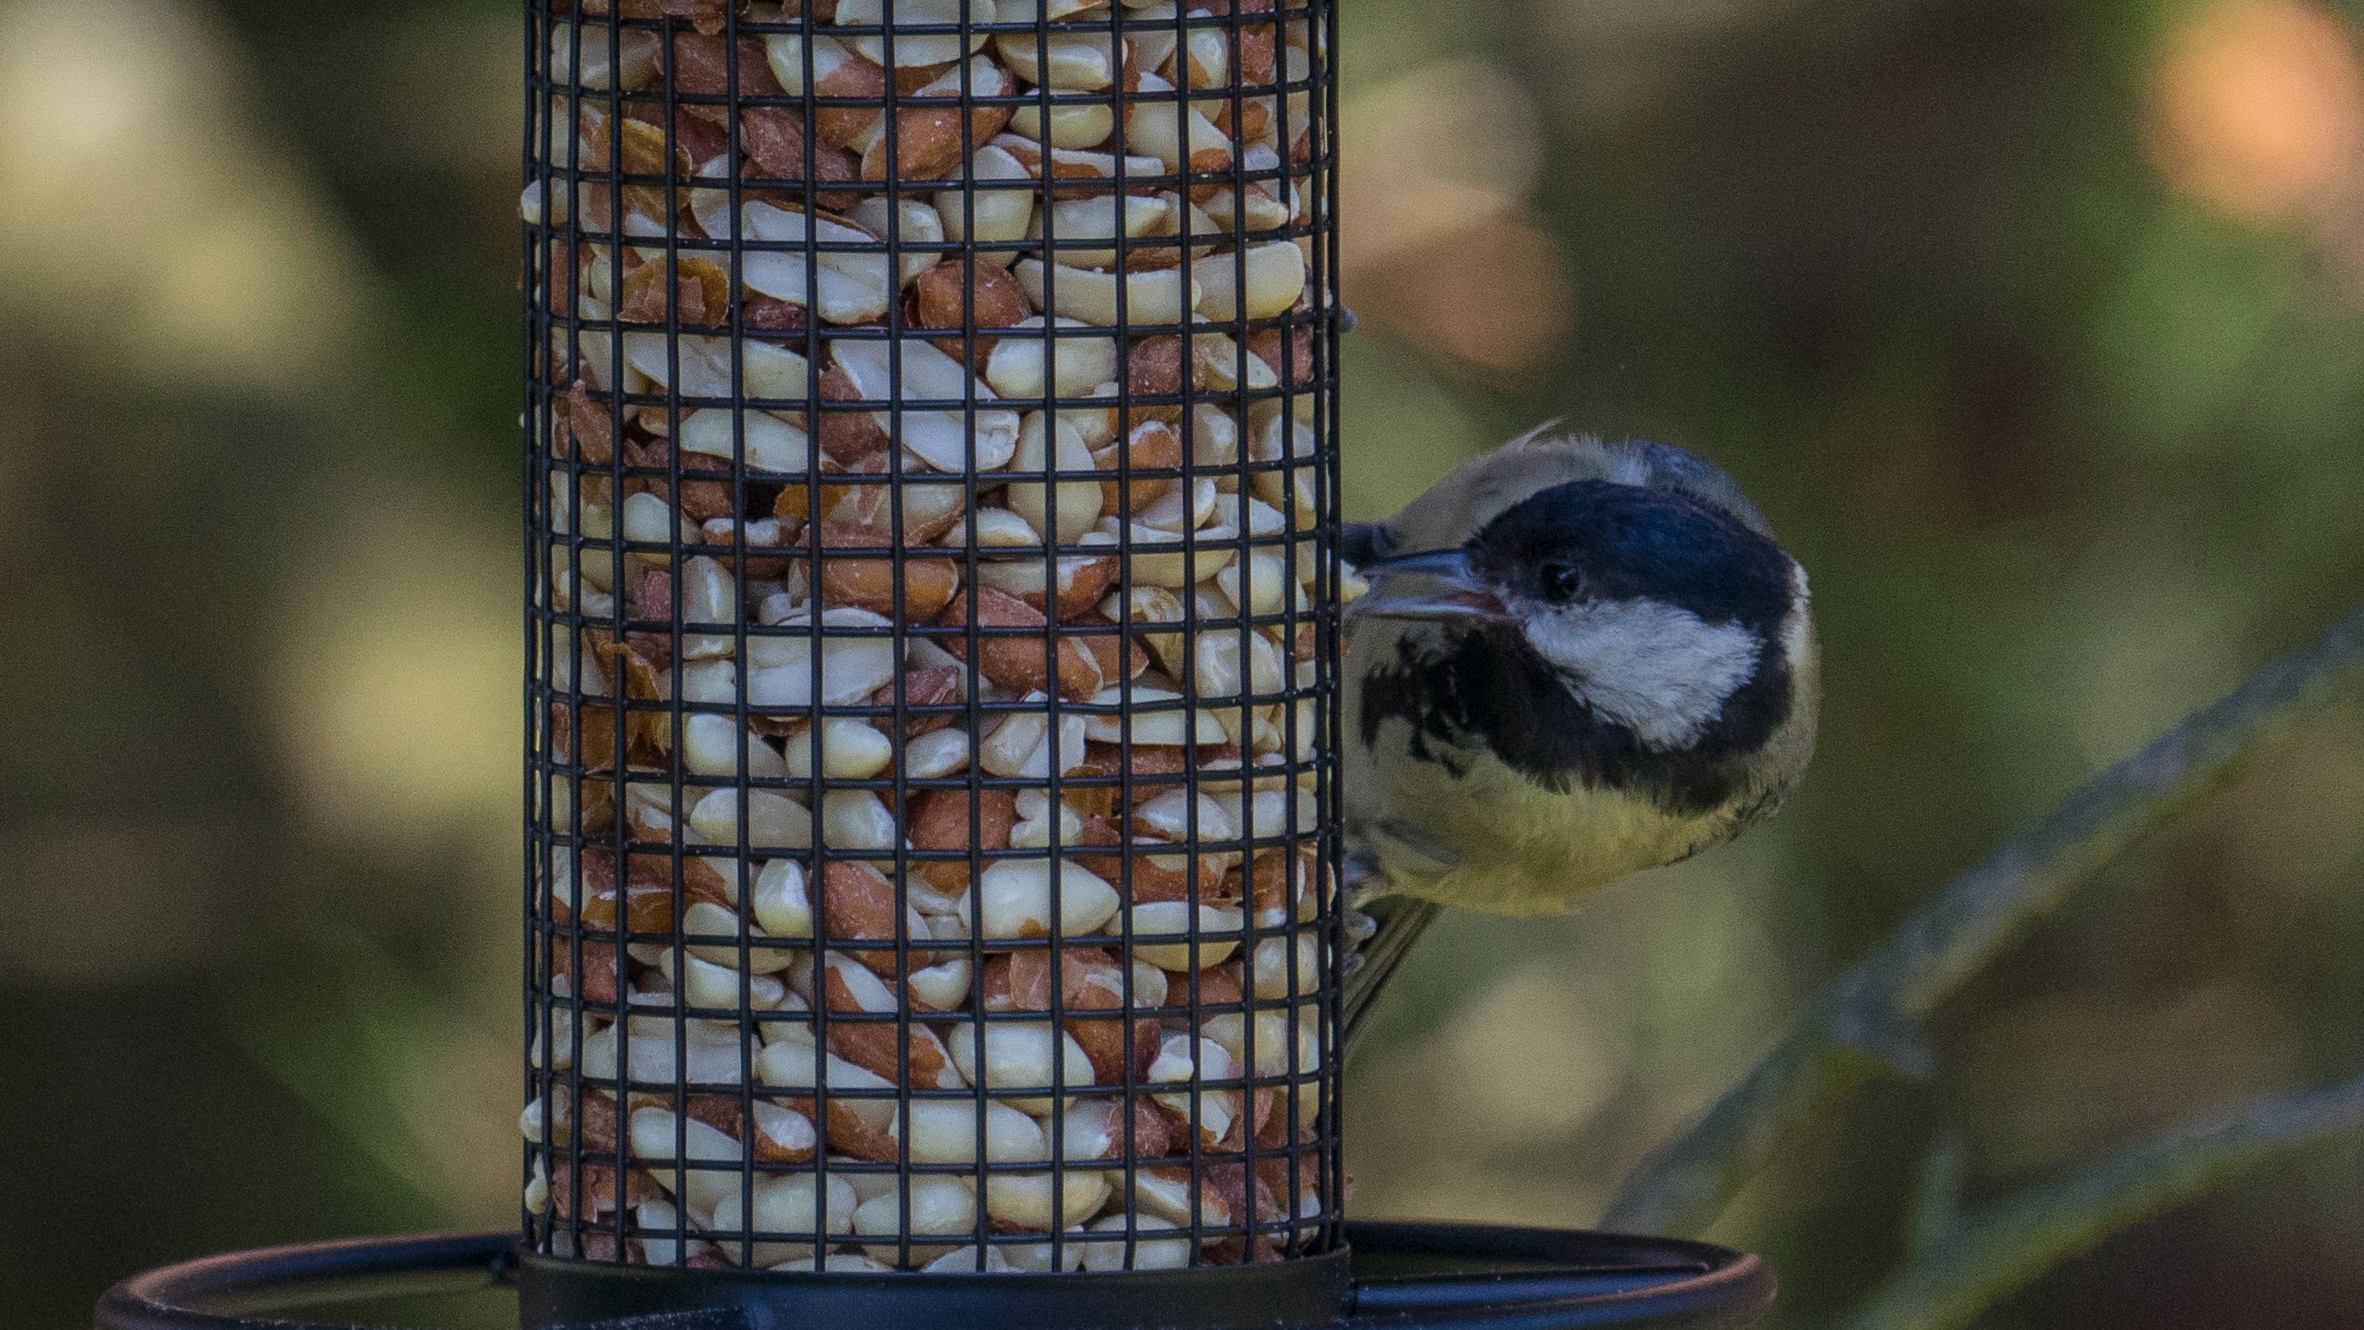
[1340,420,1820,1051]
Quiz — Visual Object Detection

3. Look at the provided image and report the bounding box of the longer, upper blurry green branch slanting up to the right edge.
[1603,607,2364,1233]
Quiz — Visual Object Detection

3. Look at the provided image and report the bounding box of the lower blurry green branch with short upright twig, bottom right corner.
[1846,1077,2364,1330]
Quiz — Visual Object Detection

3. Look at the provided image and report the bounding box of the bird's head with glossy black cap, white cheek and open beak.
[1355,480,1806,751]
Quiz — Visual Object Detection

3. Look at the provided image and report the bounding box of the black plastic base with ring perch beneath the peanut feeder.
[95,1224,1773,1330]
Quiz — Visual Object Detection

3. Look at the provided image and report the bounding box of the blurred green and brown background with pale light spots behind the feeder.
[0,0,2364,1330]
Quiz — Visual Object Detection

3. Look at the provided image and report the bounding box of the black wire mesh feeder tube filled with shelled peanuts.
[522,0,1345,1271]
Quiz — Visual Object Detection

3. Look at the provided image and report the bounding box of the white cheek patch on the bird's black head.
[1527,600,1761,751]
